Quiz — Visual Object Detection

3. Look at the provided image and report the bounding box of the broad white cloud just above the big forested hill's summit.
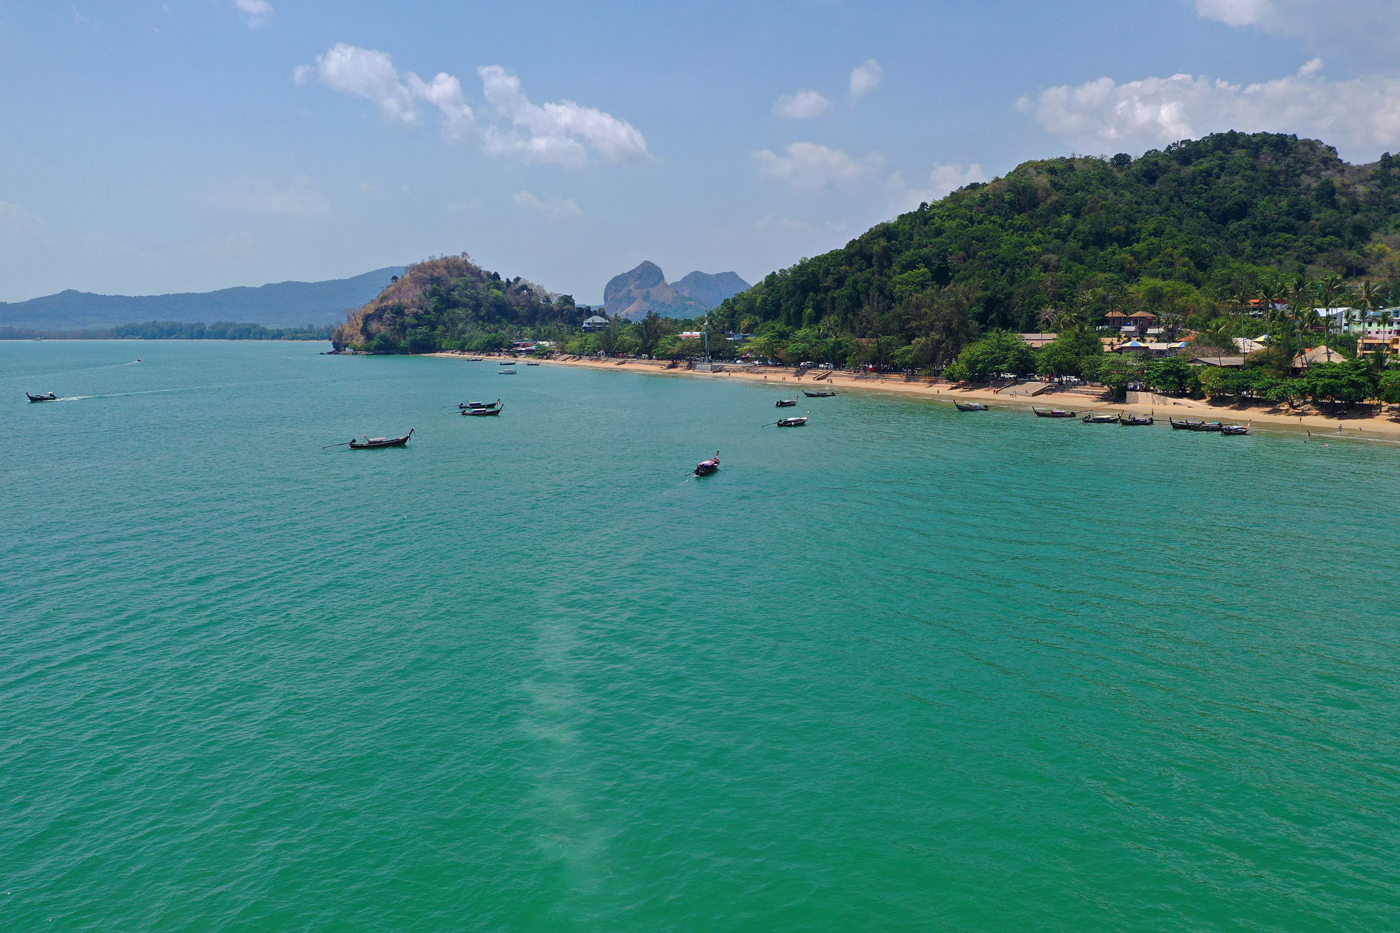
[1018,59,1400,158]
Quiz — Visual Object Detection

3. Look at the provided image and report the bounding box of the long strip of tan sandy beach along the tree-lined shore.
[423,352,1400,440]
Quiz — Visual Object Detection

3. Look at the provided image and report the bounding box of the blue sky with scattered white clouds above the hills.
[0,0,1400,301]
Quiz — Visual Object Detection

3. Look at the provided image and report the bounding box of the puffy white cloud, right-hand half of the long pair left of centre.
[476,64,650,168]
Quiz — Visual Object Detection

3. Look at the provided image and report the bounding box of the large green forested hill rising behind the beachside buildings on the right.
[713,133,1400,366]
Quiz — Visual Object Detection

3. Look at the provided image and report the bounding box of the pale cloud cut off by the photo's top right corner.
[1196,0,1400,59]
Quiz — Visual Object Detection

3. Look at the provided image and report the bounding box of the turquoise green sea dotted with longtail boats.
[0,342,1400,933]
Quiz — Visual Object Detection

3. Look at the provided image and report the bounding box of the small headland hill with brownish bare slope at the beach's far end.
[330,254,584,353]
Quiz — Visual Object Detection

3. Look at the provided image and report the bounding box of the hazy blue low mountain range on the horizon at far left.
[0,266,405,331]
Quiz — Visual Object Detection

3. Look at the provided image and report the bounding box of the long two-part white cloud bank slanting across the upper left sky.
[293,43,650,168]
